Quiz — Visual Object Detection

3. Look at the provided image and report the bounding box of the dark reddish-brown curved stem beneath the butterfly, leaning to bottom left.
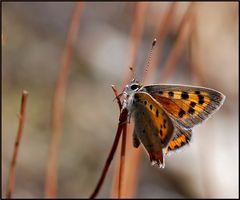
[90,109,128,199]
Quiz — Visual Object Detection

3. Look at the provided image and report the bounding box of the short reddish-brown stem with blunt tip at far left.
[6,91,28,199]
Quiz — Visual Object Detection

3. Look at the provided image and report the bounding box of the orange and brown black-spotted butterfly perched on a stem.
[122,79,225,168]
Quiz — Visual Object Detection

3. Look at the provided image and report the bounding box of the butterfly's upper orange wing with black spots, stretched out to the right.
[142,85,225,128]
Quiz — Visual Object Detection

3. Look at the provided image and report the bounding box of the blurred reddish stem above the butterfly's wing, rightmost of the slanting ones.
[160,3,194,82]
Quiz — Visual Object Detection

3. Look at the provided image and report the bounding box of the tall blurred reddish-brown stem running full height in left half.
[45,2,83,198]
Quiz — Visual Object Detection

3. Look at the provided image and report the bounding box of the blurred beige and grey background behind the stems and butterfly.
[2,2,239,198]
